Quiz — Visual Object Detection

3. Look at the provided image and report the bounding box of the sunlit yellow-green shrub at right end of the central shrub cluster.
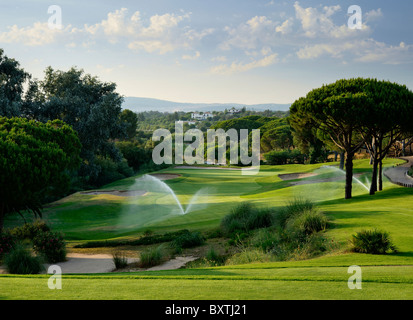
[286,209,328,235]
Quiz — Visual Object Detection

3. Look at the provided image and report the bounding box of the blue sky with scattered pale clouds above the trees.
[0,0,413,104]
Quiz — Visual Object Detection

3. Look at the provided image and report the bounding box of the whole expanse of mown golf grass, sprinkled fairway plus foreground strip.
[0,159,413,300]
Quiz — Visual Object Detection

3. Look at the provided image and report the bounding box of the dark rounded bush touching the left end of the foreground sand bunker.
[33,231,66,263]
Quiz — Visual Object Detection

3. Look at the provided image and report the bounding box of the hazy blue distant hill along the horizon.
[122,97,291,112]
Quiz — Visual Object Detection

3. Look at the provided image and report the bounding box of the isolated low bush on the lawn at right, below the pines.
[350,229,397,254]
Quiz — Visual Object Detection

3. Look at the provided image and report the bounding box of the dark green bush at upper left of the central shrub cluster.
[221,202,274,235]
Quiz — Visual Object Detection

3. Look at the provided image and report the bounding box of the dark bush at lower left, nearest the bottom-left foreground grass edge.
[4,245,43,274]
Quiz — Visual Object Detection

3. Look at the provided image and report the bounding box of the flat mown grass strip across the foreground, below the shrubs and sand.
[0,266,413,300]
